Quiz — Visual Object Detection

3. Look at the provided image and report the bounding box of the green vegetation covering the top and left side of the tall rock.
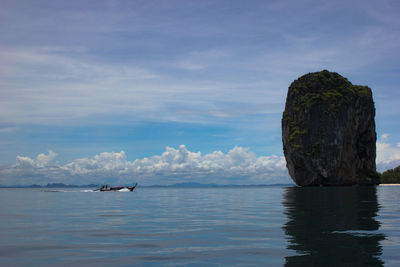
[282,70,372,159]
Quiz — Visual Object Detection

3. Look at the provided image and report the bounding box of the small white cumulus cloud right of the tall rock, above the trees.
[376,134,400,172]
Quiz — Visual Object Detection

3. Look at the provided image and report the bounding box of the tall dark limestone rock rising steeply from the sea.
[282,70,379,186]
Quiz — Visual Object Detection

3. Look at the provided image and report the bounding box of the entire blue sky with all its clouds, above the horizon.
[0,0,400,185]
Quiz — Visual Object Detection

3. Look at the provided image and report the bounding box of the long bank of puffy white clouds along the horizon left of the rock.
[0,145,289,185]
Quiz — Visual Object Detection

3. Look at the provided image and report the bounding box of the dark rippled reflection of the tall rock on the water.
[283,187,385,266]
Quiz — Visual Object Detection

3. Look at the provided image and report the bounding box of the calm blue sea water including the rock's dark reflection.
[0,186,400,266]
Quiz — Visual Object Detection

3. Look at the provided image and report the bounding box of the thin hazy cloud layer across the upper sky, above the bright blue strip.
[0,1,400,131]
